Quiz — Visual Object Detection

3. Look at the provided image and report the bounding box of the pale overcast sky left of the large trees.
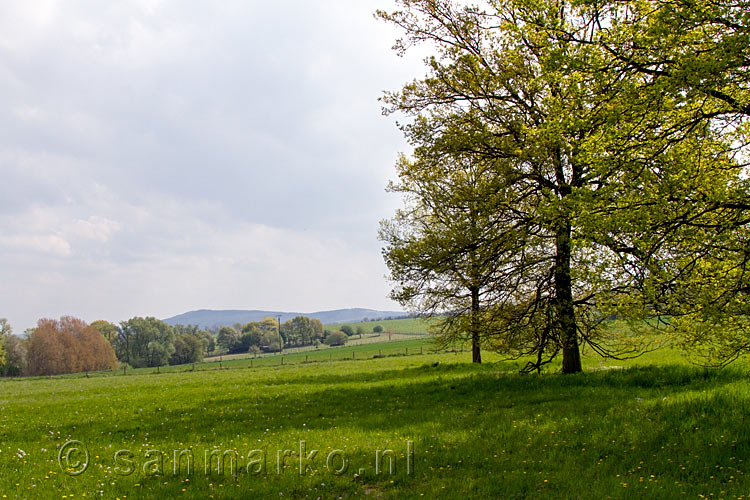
[0,0,423,333]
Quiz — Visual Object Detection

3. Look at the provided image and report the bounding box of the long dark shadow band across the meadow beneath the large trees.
[53,364,741,446]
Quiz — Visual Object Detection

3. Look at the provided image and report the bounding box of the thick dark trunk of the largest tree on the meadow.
[555,221,583,373]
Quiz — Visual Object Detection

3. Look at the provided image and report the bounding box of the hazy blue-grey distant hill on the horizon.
[164,309,406,328]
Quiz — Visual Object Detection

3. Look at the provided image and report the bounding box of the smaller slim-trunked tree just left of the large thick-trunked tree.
[380,142,512,362]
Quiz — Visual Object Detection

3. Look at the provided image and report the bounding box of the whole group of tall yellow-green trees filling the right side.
[379,0,750,373]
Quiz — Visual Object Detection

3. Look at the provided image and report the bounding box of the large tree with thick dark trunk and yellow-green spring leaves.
[380,0,747,373]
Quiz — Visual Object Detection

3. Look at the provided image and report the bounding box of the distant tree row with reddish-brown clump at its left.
[0,316,383,377]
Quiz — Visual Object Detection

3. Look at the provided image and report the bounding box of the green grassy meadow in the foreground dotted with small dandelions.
[0,344,750,499]
